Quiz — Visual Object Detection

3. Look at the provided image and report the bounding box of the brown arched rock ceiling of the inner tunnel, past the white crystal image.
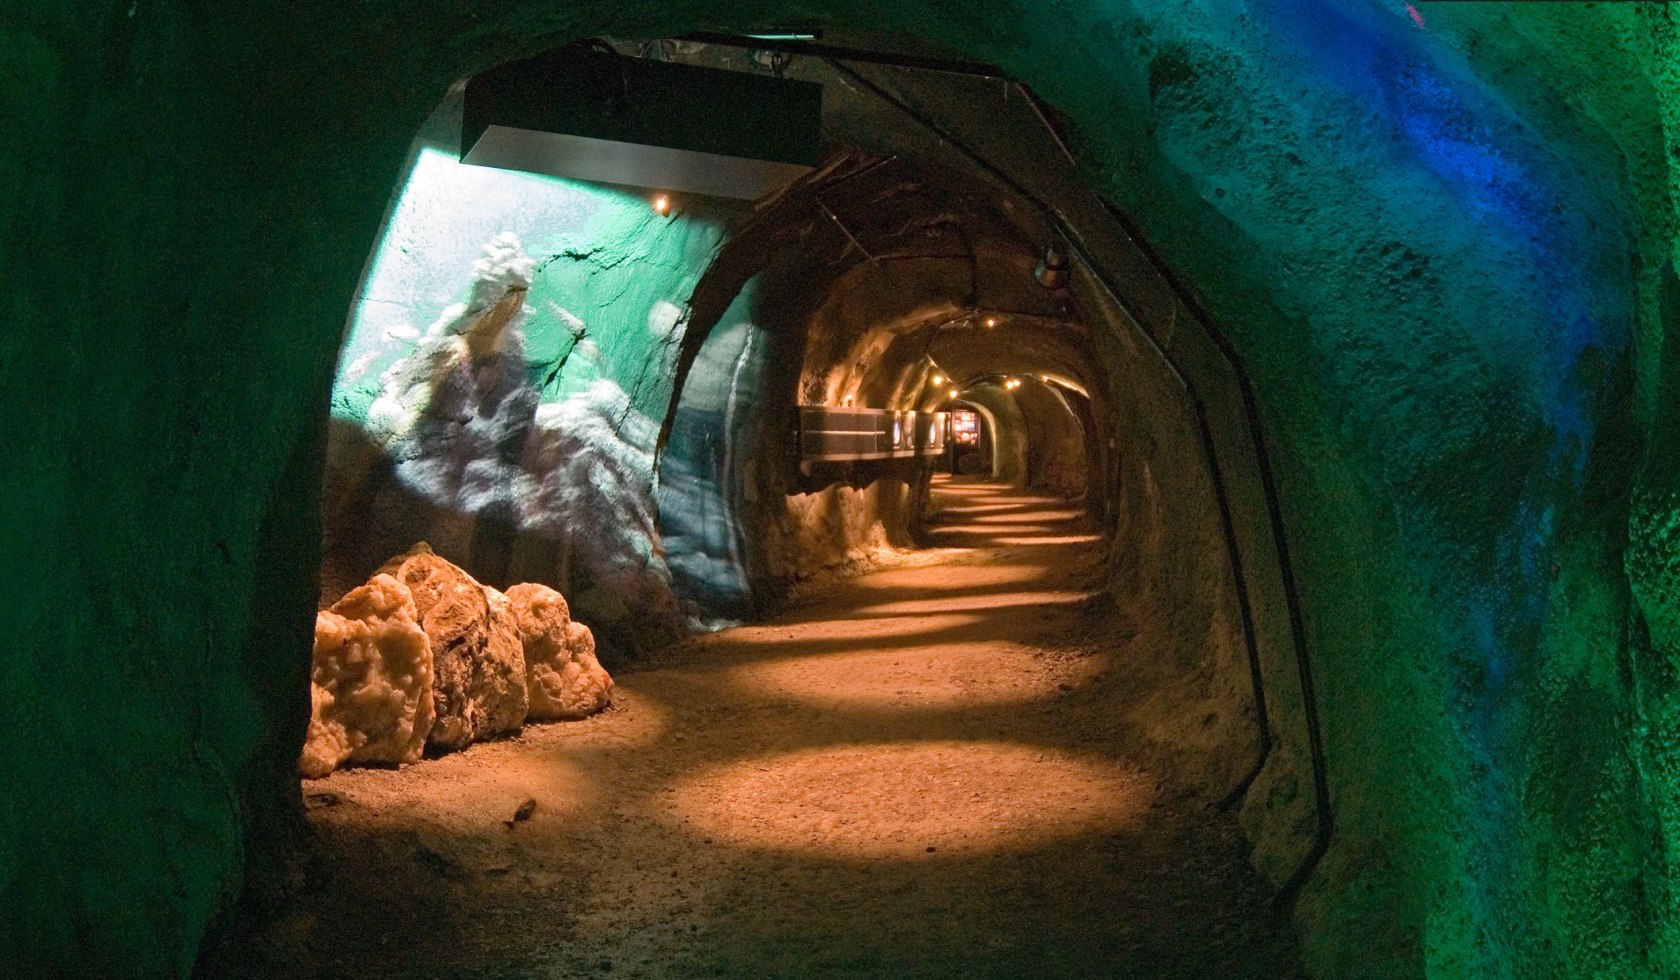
[655,150,1100,420]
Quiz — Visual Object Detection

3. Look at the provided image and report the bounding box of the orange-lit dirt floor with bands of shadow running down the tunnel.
[284,484,1297,980]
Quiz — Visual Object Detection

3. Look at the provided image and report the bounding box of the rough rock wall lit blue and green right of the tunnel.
[1021,2,1653,977]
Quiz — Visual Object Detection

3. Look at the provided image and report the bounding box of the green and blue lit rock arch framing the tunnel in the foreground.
[0,0,1680,977]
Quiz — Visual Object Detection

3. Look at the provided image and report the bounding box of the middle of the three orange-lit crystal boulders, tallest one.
[380,541,528,751]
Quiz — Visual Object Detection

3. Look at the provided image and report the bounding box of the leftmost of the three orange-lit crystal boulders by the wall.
[297,575,433,778]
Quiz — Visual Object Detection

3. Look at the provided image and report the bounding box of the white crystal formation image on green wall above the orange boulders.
[328,234,682,655]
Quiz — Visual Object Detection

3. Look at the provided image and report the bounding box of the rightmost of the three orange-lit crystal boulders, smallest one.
[507,582,613,721]
